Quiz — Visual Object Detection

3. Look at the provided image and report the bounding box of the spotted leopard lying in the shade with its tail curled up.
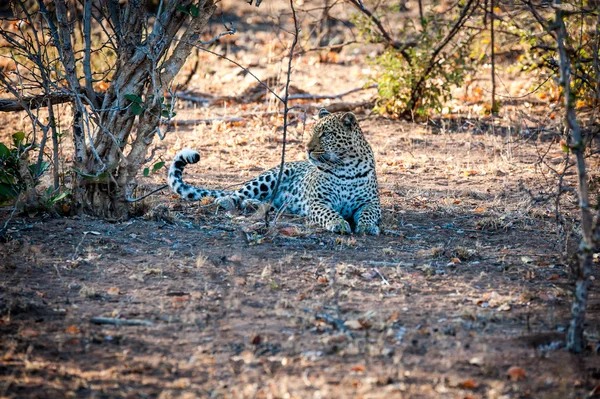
[168,108,381,235]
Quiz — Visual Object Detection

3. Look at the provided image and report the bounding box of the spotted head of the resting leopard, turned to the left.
[306,109,373,168]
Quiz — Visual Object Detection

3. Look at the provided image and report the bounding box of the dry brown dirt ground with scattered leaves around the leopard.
[0,1,600,399]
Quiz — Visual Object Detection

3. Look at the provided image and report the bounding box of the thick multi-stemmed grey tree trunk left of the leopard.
[62,0,216,220]
